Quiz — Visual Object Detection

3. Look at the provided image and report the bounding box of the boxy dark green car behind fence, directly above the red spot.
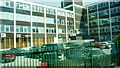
[41,44,64,67]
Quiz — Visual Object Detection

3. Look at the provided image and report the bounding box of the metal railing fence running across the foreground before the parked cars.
[1,44,119,68]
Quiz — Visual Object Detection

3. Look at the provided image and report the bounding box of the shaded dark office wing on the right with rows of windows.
[81,0,120,41]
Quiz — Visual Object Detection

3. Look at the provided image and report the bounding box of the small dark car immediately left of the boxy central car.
[26,46,41,59]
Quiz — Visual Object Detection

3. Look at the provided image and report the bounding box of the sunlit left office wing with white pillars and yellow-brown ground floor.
[0,0,75,49]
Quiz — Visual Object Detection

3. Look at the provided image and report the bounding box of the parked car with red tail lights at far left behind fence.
[2,50,16,63]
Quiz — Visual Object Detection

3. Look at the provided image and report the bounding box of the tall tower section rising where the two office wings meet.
[61,0,84,34]
